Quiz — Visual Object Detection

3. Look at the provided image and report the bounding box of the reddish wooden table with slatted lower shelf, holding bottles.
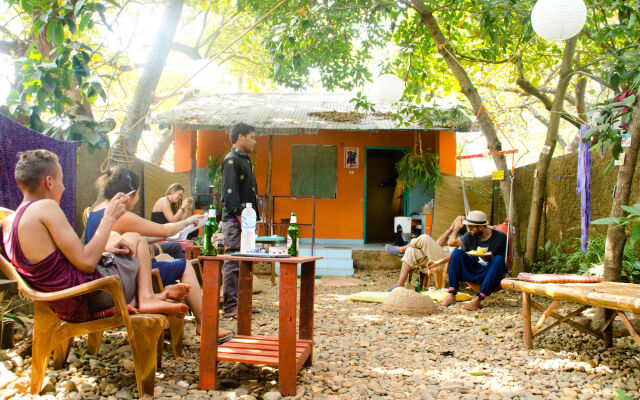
[200,254,322,396]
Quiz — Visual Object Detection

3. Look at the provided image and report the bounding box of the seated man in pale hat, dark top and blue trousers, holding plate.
[427,211,507,310]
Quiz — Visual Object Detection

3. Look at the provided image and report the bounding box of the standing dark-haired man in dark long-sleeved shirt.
[222,123,260,317]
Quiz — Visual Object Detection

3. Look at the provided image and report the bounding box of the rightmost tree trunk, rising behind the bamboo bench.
[604,101,640,282]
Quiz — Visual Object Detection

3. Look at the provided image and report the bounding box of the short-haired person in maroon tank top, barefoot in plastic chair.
[2,150,188,321]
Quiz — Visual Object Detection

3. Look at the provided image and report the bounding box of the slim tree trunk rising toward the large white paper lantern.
[524,35,578,270]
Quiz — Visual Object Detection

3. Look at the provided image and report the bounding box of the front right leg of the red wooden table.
[278,262,298,396]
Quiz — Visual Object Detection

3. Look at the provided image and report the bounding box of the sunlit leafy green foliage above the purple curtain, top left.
[7,0,119,149]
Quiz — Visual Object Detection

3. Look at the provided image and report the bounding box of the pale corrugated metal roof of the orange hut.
[151,93,468,135]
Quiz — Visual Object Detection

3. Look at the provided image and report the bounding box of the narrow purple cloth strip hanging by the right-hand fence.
[576,124,591,253]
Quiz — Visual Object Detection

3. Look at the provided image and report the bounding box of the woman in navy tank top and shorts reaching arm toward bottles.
[85,167,231,337]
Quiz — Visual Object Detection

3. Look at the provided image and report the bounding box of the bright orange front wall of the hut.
[185,130,456,240]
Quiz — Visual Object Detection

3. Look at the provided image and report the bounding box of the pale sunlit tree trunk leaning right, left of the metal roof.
[109,0,184,165]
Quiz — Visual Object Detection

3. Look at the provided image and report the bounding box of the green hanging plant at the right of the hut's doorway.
[396,135,442,193]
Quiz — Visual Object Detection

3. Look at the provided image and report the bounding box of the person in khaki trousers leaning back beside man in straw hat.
[385,215,467,292]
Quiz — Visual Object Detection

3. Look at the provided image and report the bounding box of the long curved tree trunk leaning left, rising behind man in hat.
[411,0,523,275]
